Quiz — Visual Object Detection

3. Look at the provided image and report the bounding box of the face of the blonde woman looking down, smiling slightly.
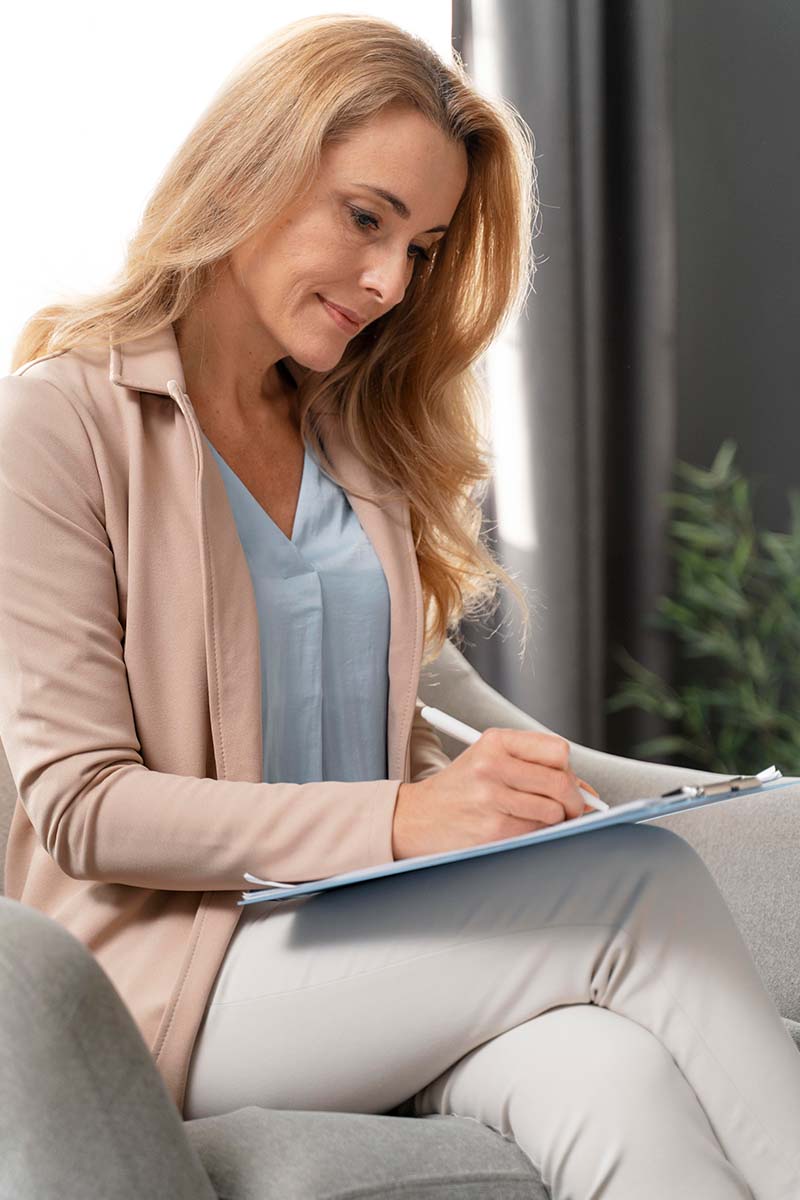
[225,109,467,371]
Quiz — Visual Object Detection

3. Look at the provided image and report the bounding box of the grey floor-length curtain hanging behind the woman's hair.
[452,0,676,754]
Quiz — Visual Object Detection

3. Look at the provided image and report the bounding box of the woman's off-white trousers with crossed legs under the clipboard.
[184,824,800,1200]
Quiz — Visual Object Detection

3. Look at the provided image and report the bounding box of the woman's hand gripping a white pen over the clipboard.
[392,727,594,860]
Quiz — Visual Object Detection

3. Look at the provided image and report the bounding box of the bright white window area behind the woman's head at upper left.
[0,0,451,374]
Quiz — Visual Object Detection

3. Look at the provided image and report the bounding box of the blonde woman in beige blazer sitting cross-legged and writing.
[0,17,800,1200]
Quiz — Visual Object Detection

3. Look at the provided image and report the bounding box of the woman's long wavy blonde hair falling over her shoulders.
[12,14,539,662]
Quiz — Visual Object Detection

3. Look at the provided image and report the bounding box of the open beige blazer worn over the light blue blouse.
[0,325,449,1112]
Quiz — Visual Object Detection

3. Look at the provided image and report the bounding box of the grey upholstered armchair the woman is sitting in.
[0,643,800,1200]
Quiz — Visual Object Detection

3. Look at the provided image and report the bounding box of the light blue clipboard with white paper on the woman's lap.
[236,767,800,907]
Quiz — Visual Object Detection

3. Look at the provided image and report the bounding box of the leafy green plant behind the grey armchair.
[607,440,800,774]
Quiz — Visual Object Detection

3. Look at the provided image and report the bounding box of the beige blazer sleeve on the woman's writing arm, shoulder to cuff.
[0,376,400,892]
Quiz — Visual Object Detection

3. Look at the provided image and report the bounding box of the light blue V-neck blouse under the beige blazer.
[204,434,390,784]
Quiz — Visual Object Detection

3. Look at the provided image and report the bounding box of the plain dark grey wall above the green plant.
[673,0,800,529]
